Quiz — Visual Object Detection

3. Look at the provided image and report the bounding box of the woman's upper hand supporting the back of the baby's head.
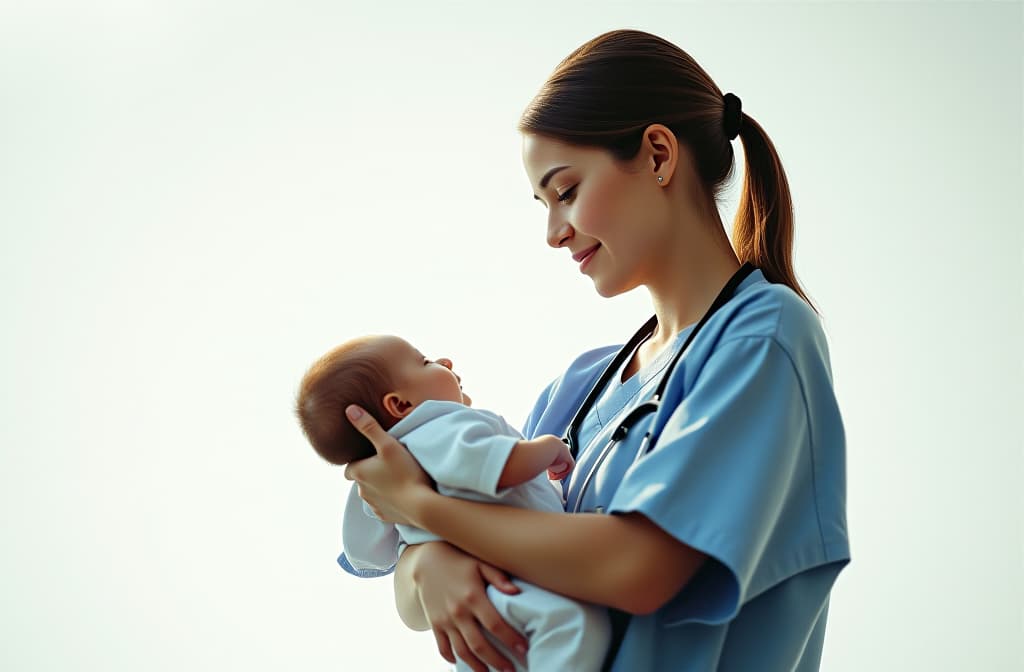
[345,406,434,527]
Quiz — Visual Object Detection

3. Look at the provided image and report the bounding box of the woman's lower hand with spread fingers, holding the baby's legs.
[399,542,526,672]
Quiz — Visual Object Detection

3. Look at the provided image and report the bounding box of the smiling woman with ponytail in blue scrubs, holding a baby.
[346,31,849,671]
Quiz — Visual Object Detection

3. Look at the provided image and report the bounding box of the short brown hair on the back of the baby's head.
[295,337,397,465]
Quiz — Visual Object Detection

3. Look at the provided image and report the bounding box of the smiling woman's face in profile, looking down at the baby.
[522,134,666,296]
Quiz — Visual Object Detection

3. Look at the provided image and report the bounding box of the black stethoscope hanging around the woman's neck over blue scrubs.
[562,262,757,513]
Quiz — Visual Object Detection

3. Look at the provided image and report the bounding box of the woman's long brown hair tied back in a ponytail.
[519,30,813,307]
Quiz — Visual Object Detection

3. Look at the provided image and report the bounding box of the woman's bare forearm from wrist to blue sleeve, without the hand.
[407,489,706,614]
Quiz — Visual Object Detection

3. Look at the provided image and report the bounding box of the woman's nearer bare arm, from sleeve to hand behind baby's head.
[345,403,706,614]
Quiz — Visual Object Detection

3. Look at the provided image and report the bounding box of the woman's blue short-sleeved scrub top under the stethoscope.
[523,270,850,672]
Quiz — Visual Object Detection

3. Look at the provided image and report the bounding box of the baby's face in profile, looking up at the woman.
[379,336,473,406]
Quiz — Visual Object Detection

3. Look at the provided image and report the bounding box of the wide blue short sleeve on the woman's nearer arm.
[608,336,842,625]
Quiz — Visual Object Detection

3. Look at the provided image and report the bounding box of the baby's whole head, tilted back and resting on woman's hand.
[295,336,472,464]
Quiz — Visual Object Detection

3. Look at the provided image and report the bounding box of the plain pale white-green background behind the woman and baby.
[0,0,1024,672]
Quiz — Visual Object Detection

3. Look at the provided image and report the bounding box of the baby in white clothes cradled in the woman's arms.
[296,336,610,672]
